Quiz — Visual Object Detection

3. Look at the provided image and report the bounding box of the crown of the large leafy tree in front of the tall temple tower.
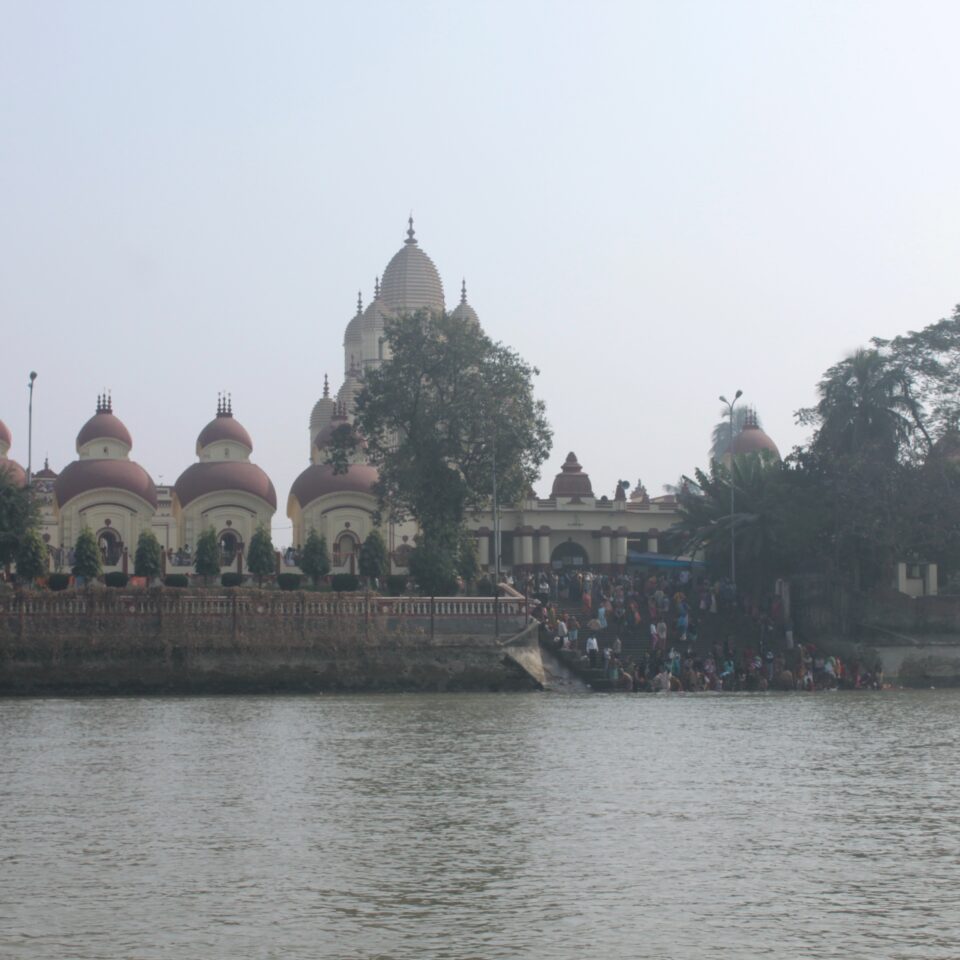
[329,310,551,558]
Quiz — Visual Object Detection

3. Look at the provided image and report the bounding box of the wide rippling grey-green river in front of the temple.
[0,691,960,960]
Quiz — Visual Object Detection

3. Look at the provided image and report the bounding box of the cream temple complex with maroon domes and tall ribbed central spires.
[0,219,777,573]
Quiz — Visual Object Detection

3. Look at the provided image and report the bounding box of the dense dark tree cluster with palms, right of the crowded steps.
[678,307,960,590]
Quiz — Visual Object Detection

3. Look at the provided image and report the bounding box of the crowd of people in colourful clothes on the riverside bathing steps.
[522,569,883,692]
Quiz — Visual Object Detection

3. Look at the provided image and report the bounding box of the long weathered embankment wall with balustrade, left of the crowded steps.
[0,590,540,695]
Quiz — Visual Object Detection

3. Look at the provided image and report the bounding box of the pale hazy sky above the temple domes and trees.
[0,0,960,544]
